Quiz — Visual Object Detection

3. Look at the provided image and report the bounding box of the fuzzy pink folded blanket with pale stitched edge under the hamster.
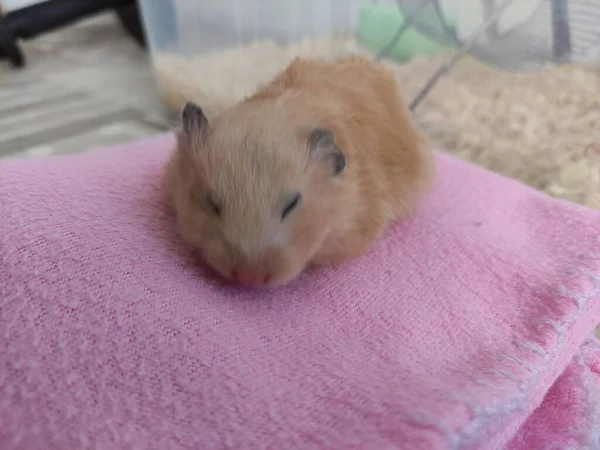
[0,135,600,450]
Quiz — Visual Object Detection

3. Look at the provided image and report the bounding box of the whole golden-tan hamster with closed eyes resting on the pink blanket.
[166,56,435,286]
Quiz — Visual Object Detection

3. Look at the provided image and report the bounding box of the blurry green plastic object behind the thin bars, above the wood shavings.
[358,2,454,62]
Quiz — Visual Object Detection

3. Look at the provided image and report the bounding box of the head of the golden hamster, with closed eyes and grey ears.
[168,102,346,286]
